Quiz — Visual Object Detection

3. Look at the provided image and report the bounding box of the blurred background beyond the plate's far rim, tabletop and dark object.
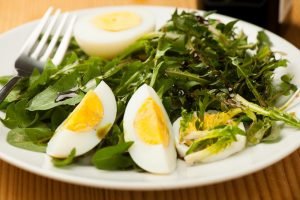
[0,0,300,48]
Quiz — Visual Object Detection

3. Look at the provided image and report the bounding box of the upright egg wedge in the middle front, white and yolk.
[123,84,177,173]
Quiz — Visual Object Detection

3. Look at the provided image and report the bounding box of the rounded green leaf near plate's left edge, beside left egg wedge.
[6,128,53,152]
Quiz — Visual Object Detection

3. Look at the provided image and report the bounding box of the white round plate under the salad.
[0,7,300,190]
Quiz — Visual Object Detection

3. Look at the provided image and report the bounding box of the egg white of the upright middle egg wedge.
[123,84,177,173]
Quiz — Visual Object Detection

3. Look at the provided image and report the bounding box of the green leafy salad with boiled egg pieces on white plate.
[0,10,300,174]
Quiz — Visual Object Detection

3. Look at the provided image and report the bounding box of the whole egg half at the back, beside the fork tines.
[74,8,155,58]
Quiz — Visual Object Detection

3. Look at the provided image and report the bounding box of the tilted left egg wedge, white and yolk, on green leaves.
[47,81,117,158]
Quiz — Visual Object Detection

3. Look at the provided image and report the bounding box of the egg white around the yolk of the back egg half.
[74,8,155,58]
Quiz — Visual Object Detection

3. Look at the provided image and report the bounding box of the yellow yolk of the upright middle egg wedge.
[134,98,169,147]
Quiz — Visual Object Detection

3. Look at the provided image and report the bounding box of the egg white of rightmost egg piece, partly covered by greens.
[173,117,246,165]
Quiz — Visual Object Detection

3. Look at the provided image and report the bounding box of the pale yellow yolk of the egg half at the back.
[93,11,142,32]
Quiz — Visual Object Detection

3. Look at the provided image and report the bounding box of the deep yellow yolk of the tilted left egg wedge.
[64,91,103,132]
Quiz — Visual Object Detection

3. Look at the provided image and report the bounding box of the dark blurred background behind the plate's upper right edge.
[197,0,300,48]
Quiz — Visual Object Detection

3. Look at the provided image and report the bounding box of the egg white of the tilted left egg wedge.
[46,81,117,158]
